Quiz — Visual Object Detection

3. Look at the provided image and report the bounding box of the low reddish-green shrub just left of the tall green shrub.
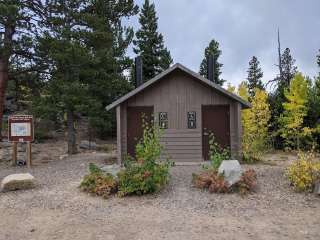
[80,163,118,198]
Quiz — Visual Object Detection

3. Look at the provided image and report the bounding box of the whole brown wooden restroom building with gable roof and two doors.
[106,60,250,162]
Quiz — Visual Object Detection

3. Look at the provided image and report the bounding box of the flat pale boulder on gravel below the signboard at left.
[0,173,35,192]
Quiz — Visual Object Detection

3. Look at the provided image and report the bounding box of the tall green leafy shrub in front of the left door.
[118,119,171,196]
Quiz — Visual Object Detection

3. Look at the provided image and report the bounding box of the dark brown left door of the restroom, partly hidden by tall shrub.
[127,106,153,157]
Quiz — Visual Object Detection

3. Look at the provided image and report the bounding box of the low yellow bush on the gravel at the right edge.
[286,150,320,192]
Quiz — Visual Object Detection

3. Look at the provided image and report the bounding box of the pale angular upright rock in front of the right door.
[218,160,242,186]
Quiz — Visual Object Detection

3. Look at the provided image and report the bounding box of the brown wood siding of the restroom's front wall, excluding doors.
[121,70,241,161]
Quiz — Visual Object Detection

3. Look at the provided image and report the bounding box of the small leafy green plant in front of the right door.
[209,133,230,169]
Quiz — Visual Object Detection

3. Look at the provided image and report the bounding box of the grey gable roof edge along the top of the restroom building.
[106,63,251,111]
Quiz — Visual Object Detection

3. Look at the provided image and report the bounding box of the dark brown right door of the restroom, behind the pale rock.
[202,105,230,160]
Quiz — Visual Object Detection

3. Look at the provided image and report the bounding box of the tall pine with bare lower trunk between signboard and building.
[39,0,91,154]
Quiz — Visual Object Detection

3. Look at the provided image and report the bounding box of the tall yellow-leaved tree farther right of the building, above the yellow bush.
[279,73,310,149]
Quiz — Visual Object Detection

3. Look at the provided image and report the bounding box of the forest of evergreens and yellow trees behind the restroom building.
[0,0,320,154]
